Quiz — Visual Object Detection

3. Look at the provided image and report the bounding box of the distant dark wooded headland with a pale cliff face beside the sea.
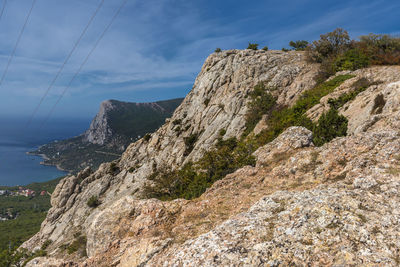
[31,98,183,173]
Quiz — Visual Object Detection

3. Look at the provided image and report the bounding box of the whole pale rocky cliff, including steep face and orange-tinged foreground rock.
[24,50,400,266]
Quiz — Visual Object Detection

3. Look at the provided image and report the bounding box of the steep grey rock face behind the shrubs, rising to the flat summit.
[25,50,318,264]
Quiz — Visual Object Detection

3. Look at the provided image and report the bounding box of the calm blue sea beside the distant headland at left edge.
[0,117,90,186]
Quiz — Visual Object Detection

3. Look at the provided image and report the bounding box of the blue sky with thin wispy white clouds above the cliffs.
[0,0,400,123]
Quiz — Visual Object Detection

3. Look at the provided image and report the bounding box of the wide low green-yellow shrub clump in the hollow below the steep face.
[144,138,256,200]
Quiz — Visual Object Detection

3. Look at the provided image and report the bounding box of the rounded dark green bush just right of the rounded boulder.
[313,108,348,146]
